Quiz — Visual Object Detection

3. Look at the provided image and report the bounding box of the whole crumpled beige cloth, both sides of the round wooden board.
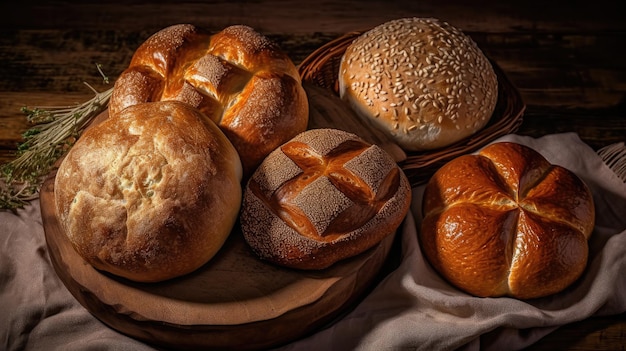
[0,134,626,351]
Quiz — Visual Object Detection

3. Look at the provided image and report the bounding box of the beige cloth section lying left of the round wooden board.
[0,200,152,351]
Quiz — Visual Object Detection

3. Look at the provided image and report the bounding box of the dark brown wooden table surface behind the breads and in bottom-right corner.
[0,0,626,350]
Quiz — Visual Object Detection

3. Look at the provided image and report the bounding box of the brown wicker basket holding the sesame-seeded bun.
[298,32,526,186]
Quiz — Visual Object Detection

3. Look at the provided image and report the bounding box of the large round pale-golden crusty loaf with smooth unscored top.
[55,101,242,282]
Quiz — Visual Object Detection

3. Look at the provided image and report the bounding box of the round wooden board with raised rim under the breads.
[40,110,394,350]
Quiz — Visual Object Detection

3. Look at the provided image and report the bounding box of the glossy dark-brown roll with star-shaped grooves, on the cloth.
[419,142,595,299]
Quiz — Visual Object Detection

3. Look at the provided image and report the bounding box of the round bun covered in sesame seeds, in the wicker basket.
[339,18,498,151]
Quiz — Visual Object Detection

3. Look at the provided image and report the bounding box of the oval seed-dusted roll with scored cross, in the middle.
[240,129,411,269]
